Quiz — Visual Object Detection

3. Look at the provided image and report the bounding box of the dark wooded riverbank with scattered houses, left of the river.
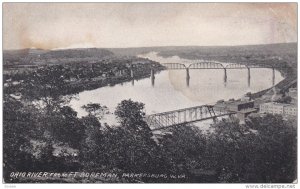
[3,57,164,99]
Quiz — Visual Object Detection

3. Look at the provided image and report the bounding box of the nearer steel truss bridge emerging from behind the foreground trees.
[145,105,236,131]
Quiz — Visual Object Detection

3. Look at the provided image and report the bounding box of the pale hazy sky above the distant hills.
[3,3,297,49]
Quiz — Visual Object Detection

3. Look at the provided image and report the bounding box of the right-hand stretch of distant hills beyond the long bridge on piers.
[109,43,297,70]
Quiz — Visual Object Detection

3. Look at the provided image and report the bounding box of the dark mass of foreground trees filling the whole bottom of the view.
[3,97,297,183]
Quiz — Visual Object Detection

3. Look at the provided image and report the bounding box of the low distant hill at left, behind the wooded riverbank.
[3,48,114,65]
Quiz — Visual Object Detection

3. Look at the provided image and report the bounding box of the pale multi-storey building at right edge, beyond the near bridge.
[259,102,297,116]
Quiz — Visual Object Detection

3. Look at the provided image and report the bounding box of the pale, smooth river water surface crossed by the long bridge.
[70,53,283,125]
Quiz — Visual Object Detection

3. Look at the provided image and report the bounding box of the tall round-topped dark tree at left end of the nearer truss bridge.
[110,99,159,175]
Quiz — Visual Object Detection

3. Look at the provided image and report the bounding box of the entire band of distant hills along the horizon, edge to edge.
[3,43,297,66]
